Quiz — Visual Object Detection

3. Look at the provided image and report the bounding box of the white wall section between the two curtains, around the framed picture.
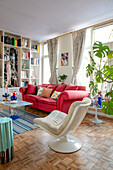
[58,34,73,84]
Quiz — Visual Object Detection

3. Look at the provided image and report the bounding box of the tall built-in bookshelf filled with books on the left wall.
[0,30,40,88]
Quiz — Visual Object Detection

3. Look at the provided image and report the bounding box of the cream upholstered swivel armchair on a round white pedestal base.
[34,97,91,153]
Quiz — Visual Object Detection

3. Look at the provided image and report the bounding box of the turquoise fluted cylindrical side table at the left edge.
[0,117,14,164]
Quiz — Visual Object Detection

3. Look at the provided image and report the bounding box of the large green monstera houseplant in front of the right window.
[86,41,113,115]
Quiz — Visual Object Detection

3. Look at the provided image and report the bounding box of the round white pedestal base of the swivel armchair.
[48,135,82,153]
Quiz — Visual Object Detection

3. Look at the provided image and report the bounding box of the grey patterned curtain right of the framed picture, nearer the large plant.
[72,29,86,84]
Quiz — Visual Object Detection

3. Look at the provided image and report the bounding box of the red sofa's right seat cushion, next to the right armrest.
[38,97,57,106]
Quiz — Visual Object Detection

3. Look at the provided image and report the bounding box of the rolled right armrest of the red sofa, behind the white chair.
[57,90,89,113]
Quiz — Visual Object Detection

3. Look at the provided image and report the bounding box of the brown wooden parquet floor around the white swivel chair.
[0,108,113,170]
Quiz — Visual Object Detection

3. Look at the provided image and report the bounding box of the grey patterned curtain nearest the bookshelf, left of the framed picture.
[48,38,58,84]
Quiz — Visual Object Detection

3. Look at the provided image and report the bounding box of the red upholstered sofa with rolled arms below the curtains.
[19,83,89,113]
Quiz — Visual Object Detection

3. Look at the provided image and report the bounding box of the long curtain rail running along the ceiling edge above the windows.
[40,18,113,43]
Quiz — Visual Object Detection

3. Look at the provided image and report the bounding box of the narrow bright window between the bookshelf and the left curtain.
[43,43,51,84]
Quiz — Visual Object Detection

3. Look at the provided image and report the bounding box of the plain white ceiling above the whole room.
[0,0,113,41]
